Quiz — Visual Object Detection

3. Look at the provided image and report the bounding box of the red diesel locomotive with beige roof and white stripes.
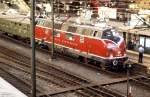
[36,18,127,69]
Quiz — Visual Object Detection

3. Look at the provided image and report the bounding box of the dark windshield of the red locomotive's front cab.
[102,29,120,43]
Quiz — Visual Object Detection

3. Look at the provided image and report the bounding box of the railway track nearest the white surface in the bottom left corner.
[0,54,51,97]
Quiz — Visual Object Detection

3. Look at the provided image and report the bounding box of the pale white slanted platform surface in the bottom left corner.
[0,77,27,97]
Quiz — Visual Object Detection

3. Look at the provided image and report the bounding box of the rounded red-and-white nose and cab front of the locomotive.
[102,29,128,69]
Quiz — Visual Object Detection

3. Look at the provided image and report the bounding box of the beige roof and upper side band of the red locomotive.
[37,17,111,37]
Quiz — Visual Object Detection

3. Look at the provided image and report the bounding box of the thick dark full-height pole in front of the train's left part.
[30,0,36,97]
